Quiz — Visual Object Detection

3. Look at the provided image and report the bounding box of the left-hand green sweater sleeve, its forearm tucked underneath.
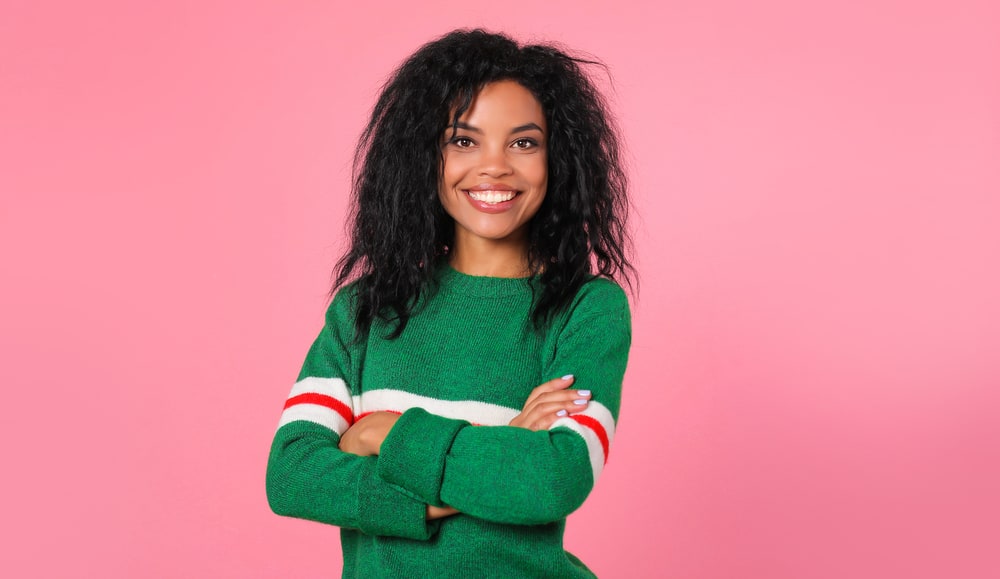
[266,291,438,539]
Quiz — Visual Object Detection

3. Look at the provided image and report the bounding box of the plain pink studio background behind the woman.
[0,0,1000,579]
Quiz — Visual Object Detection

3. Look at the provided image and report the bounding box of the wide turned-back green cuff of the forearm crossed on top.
[378,408,469,506]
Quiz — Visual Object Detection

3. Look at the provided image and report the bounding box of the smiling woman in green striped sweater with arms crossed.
[267,30,632,577]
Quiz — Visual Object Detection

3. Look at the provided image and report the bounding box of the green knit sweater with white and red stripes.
[267,266,631,578]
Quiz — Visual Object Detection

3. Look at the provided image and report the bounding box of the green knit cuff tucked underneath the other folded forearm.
[358,460,439,541]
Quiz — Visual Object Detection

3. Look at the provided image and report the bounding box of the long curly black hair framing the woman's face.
[331,30,635,338]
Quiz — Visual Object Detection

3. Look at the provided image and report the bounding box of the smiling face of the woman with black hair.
[438,81,548,251]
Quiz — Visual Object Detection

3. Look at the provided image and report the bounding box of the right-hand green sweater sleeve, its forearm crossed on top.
[378,282,631,524]
